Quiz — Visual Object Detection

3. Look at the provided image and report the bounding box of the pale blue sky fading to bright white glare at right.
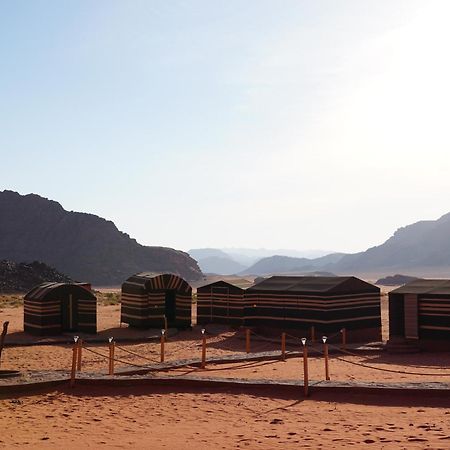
[0,0,450,252]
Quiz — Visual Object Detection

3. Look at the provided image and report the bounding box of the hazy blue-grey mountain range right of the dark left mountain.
[190,213,450,277]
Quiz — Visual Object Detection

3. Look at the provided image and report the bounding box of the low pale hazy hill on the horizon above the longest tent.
[241,253,344,275]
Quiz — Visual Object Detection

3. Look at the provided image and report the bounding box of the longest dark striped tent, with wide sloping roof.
[244,276,381,338]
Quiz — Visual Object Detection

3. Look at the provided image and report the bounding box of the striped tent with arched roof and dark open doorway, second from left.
[121,272,192,328]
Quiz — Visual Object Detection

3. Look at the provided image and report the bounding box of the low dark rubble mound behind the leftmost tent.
[0,260,73,293]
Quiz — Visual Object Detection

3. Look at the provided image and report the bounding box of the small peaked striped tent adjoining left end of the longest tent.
[197,281,244,325]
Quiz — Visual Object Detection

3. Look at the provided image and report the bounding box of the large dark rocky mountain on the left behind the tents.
[0,191,202,285]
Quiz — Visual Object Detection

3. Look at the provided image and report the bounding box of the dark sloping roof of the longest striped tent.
[247,276,379,292]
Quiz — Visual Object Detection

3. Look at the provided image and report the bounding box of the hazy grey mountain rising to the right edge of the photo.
[332,213,450,274]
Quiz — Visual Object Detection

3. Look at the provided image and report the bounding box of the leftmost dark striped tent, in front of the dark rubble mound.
[24,283,97,335]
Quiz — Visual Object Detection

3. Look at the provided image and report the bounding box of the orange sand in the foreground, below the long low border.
[0,387,450,449]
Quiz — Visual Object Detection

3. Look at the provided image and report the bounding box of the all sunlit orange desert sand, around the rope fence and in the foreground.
[0,292,450,449]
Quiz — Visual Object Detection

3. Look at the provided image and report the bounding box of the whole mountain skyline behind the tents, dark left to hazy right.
[0,191,450,285]
